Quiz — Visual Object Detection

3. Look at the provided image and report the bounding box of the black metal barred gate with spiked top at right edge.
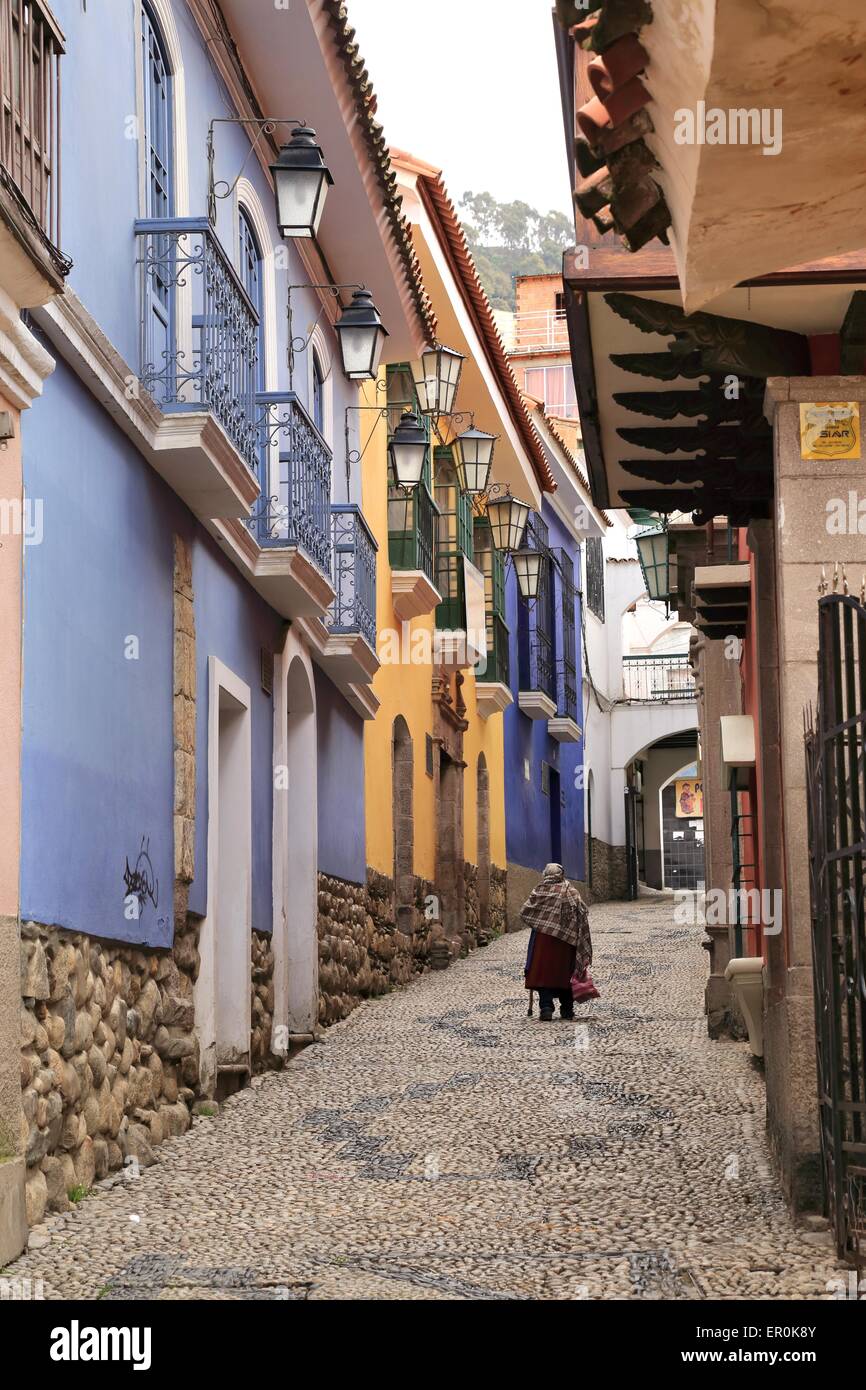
[806,594,866,1268]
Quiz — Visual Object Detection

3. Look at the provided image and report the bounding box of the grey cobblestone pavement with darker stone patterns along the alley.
[7,899,844,1300]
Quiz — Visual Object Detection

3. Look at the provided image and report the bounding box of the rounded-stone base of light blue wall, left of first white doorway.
[21,922,199,1225]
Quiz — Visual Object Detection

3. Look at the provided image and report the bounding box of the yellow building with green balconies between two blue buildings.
[357,150,545,955]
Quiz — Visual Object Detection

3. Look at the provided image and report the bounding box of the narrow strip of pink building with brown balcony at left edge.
[0,0,70,1266]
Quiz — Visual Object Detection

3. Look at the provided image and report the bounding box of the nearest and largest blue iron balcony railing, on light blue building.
[135,217,260,473]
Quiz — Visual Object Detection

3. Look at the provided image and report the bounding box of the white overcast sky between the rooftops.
[348,0,571,218]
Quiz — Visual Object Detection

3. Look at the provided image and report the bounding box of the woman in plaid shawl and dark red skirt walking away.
[520,865,592,1023]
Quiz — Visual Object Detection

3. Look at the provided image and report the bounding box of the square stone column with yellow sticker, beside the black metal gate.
[759,377,866,1209]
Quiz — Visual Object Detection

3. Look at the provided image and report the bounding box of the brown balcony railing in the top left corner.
[0,0,65,246]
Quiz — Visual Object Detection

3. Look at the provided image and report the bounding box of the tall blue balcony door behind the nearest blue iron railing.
[142,6,177,403]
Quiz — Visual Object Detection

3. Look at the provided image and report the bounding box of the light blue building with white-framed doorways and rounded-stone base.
[14,0,435,1220]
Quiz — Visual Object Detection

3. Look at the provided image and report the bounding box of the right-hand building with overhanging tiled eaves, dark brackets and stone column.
[556,0,866,1252]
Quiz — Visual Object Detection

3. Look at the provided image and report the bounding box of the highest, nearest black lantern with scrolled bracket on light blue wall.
[207,115,334,238]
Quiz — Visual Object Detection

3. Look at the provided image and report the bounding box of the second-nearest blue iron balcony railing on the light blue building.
[246,392,331,575]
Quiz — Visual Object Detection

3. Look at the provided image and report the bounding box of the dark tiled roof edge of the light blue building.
[324,0,436,342]
